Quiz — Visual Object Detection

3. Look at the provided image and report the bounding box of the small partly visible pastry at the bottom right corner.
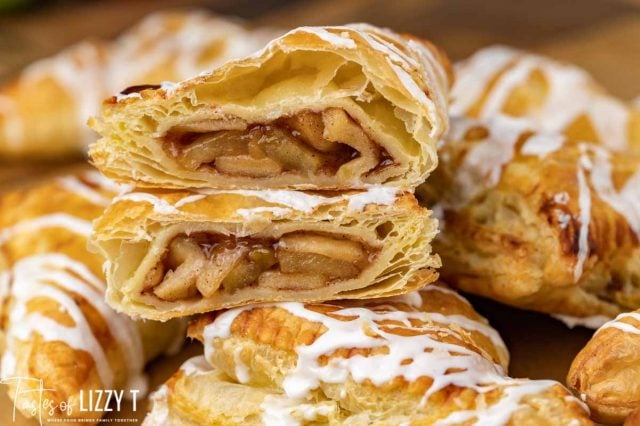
[567,311,640,424]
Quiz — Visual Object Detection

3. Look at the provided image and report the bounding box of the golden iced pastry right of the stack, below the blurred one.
[418,117,640,327]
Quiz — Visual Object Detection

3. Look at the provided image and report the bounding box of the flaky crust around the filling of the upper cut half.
[90,24,450,189]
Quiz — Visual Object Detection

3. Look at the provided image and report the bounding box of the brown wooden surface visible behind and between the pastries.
[0,0,640,425]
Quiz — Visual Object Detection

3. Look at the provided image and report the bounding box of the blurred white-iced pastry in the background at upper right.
[450,46,640,153]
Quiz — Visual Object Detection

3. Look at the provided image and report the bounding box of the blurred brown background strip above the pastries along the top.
[0,0,640,98]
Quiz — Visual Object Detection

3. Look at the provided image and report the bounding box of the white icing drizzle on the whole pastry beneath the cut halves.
[203,286,584,424]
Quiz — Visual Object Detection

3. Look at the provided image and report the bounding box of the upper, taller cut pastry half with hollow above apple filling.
[90,24,449,189]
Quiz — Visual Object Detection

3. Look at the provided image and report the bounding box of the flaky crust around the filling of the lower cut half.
[92,187,440,320]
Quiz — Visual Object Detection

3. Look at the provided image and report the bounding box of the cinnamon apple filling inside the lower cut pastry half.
[144,232,375,301]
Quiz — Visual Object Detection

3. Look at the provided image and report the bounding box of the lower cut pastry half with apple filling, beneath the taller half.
[93,187,440,320]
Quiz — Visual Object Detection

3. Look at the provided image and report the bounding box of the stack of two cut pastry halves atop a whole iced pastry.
[90,25,590,425]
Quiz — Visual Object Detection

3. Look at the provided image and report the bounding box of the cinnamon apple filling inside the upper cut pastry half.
[165,108,393,178]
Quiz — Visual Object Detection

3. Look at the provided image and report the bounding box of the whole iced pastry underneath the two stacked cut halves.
[145,284,591,426]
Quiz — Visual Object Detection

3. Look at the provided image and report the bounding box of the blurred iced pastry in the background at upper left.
[0,11,279,158]
